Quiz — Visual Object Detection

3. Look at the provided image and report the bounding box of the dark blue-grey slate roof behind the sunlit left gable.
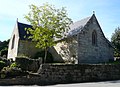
[17,22,32,40]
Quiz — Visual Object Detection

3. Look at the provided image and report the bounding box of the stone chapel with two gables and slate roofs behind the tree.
[8,14,114,64]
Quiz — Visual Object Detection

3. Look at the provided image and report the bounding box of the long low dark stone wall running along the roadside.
[0,64,120,85]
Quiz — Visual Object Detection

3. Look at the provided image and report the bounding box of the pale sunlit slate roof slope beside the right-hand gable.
[67,16,91,36]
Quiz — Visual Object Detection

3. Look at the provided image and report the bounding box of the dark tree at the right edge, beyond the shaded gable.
[111,27,120,57]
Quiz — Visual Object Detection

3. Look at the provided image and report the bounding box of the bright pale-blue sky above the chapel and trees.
[0,0,120,41]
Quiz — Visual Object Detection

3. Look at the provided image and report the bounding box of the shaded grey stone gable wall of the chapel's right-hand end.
[78,14,114,63]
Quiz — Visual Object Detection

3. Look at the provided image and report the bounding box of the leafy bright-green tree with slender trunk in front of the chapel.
[25,3,72,62]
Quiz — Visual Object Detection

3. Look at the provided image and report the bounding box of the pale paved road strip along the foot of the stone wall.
[4,80,120,87]
